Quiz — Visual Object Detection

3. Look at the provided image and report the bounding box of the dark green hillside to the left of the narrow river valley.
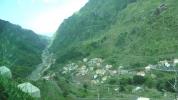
[0,20,47,77]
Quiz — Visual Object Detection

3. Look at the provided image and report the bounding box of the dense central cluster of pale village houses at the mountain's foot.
[62,58,118,84]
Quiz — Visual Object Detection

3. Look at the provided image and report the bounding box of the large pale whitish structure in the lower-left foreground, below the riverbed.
[17,82,41,98]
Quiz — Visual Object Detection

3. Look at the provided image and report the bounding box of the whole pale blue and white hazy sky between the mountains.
[0,0,88,35]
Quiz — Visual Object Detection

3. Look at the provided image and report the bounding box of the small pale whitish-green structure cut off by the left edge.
[0,66,12,78]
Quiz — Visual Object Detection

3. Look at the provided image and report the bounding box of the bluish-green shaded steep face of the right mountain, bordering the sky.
[52,0,135,62]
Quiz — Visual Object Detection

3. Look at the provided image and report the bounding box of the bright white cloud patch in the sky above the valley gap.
[27,0,86,34]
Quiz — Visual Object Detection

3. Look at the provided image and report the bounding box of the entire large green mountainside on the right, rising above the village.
[51,0,178,67]
